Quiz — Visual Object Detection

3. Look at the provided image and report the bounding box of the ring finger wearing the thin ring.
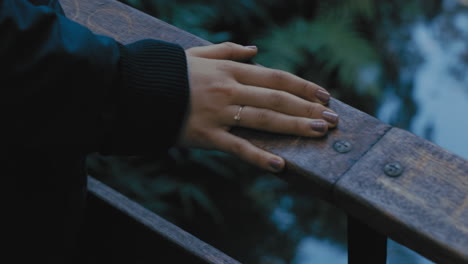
[226,106,329,137]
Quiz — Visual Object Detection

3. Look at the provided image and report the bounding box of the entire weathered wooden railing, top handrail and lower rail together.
[60,0,468,264]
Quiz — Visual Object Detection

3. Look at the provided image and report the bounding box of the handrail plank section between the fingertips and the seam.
[234,99,390,200]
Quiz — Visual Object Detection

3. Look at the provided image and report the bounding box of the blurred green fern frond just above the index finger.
[257,14,381,93]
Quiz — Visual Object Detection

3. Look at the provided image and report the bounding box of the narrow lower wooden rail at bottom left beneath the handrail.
[88,177,239,264]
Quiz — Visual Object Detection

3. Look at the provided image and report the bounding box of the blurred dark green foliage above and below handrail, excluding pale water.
[89,0,441,263]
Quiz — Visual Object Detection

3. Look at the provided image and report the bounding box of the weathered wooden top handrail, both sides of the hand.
[57,0,468,263]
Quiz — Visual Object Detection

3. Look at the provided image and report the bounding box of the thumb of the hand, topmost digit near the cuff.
[187,42,257,61]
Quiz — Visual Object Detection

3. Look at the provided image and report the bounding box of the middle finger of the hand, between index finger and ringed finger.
[232,85,338,127]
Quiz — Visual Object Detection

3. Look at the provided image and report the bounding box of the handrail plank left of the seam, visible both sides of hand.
[61,0,390,200]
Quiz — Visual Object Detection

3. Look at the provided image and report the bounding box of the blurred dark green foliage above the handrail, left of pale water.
[122,0,441,115]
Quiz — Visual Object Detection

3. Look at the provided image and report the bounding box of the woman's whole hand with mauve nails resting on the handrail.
[180,43,338,172]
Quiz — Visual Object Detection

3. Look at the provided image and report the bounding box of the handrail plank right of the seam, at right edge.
[335,128,468,263]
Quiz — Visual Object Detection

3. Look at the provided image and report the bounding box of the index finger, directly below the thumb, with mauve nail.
[229,63,330,104]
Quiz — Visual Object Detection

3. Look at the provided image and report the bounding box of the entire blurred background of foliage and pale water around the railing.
[89,0,468,264]
